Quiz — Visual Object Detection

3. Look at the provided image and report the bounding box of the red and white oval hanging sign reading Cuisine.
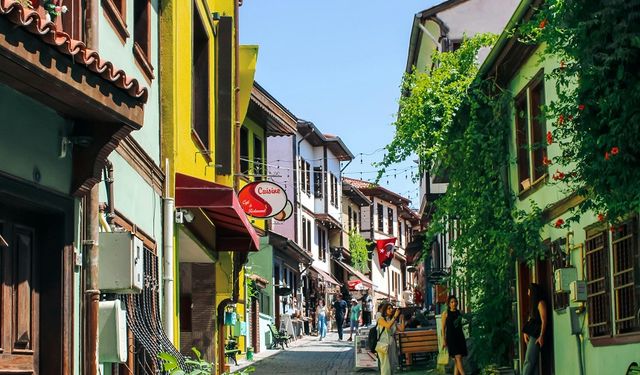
[238,181,288,219]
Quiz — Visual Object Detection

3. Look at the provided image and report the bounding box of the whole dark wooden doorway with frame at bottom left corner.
[0,184,73,374]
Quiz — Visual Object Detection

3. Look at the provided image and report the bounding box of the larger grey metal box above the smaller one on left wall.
[98,232,144,294]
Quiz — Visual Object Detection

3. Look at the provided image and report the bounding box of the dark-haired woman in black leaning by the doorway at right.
[522,283,547,375]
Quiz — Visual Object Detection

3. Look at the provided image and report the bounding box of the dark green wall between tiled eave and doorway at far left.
[0,84,72,194]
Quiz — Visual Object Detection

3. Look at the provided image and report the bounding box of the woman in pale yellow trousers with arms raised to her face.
[376,302,404,375]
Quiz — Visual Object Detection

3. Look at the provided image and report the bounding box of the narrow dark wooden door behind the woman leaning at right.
[536,258,555,375]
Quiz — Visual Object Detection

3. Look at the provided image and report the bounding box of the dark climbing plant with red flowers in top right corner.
[519,0,640,224]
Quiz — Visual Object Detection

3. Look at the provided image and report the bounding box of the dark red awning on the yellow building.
[176,173,260,251]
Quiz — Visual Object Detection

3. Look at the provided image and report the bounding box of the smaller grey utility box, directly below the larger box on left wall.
[98,299,128,363]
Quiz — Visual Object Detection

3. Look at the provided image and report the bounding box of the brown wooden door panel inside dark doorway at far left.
[0,218,40,374]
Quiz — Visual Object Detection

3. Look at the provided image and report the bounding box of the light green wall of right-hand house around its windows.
[509,45,640,375]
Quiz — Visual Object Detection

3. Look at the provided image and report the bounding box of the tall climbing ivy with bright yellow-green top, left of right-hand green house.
[379,34,542,366]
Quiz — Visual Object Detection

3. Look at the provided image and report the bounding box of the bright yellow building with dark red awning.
[160,0,259,373]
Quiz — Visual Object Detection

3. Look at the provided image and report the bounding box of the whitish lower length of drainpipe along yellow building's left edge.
[162,159,176,343]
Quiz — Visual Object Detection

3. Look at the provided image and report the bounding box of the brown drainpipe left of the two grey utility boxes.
[83,184,100,375]
